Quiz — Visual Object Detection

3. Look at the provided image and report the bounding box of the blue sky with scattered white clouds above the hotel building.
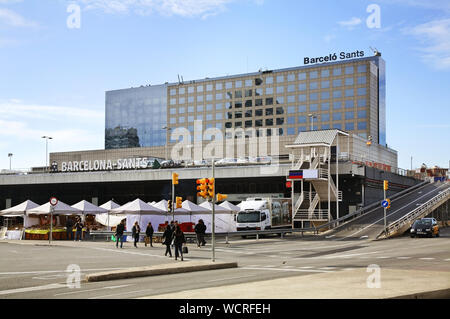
[0,0,450,170]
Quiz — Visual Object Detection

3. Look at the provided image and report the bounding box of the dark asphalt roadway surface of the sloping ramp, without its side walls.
[323,183,450,240]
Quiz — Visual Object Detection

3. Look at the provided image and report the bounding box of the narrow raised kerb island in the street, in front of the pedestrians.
[86,262,238,282]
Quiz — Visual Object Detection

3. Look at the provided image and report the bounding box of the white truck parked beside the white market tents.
[236,198,292,231]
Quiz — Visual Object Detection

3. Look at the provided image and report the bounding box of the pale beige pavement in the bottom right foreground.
[144,268,450,299]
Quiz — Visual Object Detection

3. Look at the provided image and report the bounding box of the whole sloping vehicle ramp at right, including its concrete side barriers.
[323,182,450,240]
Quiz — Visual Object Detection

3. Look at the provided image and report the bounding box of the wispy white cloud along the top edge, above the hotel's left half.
[78,0,248,18]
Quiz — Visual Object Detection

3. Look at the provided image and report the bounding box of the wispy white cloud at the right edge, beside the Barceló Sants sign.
[403,19,450,70]
